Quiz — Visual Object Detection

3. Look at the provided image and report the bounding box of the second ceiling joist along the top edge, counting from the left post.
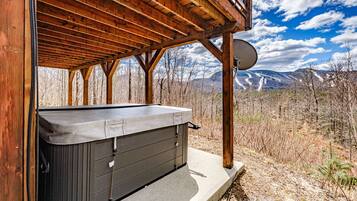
[75,0,176,39]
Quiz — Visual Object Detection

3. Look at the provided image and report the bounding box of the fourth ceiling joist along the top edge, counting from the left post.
[152,0,213,31]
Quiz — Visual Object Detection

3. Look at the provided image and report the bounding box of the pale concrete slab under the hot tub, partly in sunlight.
[124,148,244,201]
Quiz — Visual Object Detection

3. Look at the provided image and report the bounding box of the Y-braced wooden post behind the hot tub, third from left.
[101,59,120,104]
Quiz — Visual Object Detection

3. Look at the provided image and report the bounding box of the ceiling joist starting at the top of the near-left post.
[38,0,163,42]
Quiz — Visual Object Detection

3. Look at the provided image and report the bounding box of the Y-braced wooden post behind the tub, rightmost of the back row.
[135,49,165,104]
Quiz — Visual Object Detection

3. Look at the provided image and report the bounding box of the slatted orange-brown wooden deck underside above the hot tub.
[37,0,251,69]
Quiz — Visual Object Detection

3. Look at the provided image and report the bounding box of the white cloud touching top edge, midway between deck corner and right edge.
[277,0,323,21]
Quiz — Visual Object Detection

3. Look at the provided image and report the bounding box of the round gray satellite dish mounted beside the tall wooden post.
[233,39,258,70]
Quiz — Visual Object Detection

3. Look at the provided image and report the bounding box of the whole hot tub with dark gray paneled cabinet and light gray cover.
[39,106,191,201]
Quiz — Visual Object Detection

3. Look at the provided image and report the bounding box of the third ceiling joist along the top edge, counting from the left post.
[113,0,194,36]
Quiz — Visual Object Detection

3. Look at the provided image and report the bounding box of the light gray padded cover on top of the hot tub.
[39,105,192,145]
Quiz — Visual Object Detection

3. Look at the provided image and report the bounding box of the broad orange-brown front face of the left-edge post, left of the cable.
[0,0,25,201]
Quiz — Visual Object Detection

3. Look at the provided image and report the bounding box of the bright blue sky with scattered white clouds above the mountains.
[183,0,357,71]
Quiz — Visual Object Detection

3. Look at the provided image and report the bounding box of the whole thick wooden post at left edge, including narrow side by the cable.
[0,0,31,201]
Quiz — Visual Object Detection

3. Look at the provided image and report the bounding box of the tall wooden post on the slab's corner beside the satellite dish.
[222,32,234,168]
